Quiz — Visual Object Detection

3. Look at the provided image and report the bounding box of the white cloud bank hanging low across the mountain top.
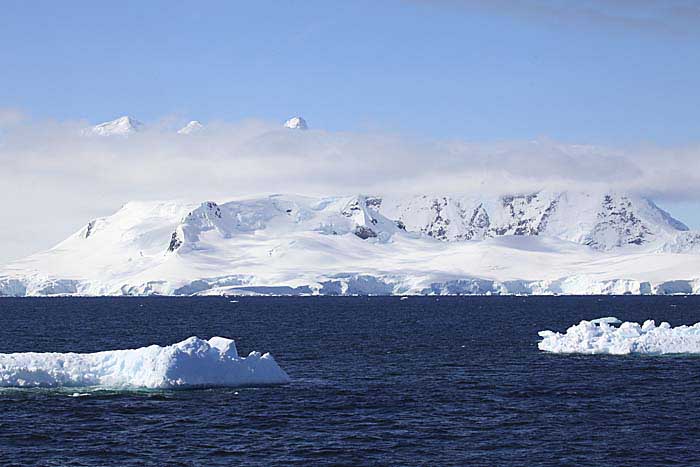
[0,111,700,262]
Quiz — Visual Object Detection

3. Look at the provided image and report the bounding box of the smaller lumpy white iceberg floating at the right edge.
[537,317,700,355]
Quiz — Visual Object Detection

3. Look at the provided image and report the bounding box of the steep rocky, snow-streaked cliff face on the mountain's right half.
[375,192,690,250]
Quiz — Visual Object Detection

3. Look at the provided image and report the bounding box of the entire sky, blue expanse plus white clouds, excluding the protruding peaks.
[0,0,700,262]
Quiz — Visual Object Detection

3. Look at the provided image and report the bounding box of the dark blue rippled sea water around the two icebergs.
[0,297,700,467]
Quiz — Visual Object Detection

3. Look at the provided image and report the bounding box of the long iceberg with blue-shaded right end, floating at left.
[0,337,289,389]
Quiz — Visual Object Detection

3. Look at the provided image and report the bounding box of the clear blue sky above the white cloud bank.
[0,0,700,144]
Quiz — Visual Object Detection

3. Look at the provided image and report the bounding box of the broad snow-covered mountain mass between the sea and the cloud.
[0,192,700,296]
